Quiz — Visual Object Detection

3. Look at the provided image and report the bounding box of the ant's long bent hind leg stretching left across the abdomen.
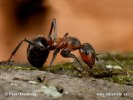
[7,38,45,62]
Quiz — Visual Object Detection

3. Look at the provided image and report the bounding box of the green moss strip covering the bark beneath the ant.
[0,52,133,84]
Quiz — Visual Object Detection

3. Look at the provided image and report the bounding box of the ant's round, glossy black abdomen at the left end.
[27,36,49,68]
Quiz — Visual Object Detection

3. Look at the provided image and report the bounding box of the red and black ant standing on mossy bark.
[7,19,97,69]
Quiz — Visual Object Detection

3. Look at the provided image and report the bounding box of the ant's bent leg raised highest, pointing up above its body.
[48,18,57,41]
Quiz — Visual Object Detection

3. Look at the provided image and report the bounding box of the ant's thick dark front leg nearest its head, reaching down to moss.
[60,49,84,69]
